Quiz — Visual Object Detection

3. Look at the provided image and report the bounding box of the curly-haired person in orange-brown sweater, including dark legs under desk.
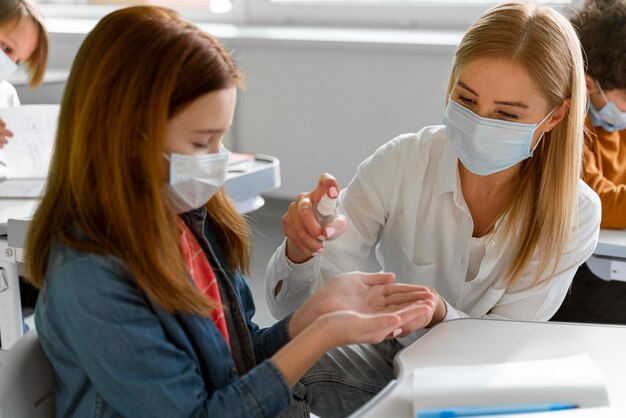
[552,0,626,324]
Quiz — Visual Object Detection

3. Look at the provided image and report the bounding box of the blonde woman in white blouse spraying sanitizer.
[266,2,601,414]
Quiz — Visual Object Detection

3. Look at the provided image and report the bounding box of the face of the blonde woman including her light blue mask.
[446,58,560,175]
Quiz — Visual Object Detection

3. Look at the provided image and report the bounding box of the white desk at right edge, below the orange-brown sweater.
[587,229,626,282]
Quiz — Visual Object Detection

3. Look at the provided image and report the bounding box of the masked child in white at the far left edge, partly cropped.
[0,0,48,149]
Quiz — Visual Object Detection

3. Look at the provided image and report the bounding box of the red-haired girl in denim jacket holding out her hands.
[25,6,435,417]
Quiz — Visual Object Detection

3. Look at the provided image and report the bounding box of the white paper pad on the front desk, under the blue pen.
[413,354,609,416]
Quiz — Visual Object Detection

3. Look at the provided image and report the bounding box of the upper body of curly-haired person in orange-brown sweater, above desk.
[572,0,626,228]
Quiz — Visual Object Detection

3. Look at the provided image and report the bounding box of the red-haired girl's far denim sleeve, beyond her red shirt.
[235,274,291,363]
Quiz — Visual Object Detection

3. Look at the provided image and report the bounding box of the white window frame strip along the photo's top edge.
[40,0,583,30]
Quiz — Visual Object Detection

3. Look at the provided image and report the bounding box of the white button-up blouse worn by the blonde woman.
[265,126,601,332]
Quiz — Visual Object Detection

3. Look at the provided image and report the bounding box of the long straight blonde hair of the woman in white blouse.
[448,2,586,285]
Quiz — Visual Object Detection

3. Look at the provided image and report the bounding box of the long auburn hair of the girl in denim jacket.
[25,6,250,316]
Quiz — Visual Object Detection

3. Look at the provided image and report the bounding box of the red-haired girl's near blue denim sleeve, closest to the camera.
[37,256,291,417]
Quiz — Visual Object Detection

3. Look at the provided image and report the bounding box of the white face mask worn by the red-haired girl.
[164,148,230,213]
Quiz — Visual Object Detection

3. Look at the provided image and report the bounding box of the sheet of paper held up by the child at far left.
[0,105,59,179]
